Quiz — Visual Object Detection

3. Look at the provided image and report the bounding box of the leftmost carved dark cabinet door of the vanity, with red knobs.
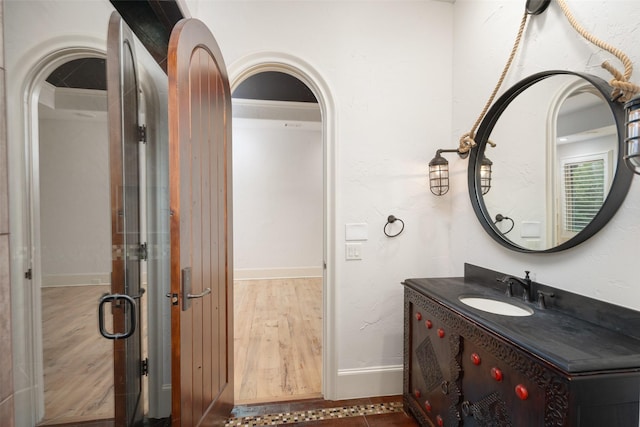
[405,300,462,426]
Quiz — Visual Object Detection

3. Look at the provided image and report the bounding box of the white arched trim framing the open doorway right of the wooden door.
[228,52,338,400]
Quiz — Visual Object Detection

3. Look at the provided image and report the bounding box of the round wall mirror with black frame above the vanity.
[468,71,633,252]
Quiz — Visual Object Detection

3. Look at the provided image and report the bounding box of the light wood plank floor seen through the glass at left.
[41,285,114,425]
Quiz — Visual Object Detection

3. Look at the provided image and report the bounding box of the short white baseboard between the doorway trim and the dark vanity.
[336,365,403,400]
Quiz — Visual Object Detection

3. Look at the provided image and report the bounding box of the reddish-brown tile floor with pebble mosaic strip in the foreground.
[225,396,418,427]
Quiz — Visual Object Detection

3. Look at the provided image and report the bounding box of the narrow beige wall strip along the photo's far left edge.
[0,0,14,427]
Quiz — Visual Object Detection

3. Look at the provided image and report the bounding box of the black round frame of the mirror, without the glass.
[468,70,633,253]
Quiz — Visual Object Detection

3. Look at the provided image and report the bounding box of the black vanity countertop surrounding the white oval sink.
[403,277,640,374]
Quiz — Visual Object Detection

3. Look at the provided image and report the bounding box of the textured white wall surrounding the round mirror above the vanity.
[450,0,640,309]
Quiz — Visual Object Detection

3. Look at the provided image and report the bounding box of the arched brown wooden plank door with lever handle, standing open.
[168,19,233,427]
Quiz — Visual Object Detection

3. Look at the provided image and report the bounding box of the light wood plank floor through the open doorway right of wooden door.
[234,278,322,404]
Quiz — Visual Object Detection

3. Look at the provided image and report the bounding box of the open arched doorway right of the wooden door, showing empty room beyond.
[233,71,323,403]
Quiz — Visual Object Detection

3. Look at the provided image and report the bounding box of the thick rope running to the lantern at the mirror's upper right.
[557,0,640,102]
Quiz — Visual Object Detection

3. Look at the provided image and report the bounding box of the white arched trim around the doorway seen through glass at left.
[19,43,106,424]
